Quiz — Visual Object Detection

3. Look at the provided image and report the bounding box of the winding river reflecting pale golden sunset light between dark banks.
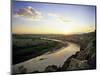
[13,38,80,73]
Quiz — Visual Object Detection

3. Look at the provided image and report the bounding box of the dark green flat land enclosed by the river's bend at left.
[13,35,68,64]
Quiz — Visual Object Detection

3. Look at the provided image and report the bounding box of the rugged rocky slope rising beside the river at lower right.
[62,39,96,70]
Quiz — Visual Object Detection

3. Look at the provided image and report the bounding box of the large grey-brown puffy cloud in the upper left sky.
[14,6,42,20]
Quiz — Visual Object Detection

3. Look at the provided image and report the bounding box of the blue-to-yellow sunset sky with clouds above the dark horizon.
[12,1,96,34]
